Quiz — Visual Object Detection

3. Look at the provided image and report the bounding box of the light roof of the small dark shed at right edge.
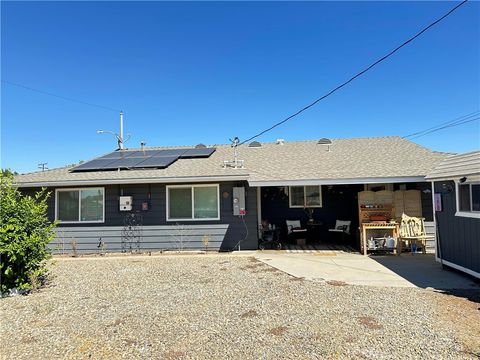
[427,151,480,179]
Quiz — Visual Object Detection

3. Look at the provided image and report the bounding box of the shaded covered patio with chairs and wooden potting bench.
[257,179,435,253]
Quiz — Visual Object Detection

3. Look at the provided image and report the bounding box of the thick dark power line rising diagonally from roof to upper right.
[239,0,468,145]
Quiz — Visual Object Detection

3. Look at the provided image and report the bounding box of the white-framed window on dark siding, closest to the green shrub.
[55,188,105,223]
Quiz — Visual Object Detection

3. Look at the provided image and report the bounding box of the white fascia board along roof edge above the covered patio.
[248,176,427,187]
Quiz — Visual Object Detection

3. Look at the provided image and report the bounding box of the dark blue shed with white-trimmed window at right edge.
[426,151,480,278]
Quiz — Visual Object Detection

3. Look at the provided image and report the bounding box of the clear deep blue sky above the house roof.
[1,2,480,172]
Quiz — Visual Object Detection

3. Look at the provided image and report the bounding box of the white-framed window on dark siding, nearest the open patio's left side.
[167,185,220,221]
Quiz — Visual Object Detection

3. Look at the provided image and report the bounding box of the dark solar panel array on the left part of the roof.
[72,148,215,171]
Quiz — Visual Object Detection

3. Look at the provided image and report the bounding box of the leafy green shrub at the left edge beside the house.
[0,171,55,293]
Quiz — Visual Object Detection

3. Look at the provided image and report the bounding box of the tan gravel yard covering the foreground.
[0,255,480,359]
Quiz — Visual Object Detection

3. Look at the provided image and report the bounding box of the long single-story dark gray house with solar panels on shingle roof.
[16,137,448,252]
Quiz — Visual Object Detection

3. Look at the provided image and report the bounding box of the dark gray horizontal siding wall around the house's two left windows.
[21,182,258,251]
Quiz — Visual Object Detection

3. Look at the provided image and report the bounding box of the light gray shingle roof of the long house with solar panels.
[16,136,450,187]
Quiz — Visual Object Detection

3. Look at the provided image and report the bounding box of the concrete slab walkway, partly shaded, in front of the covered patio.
[255,251,480,291]
